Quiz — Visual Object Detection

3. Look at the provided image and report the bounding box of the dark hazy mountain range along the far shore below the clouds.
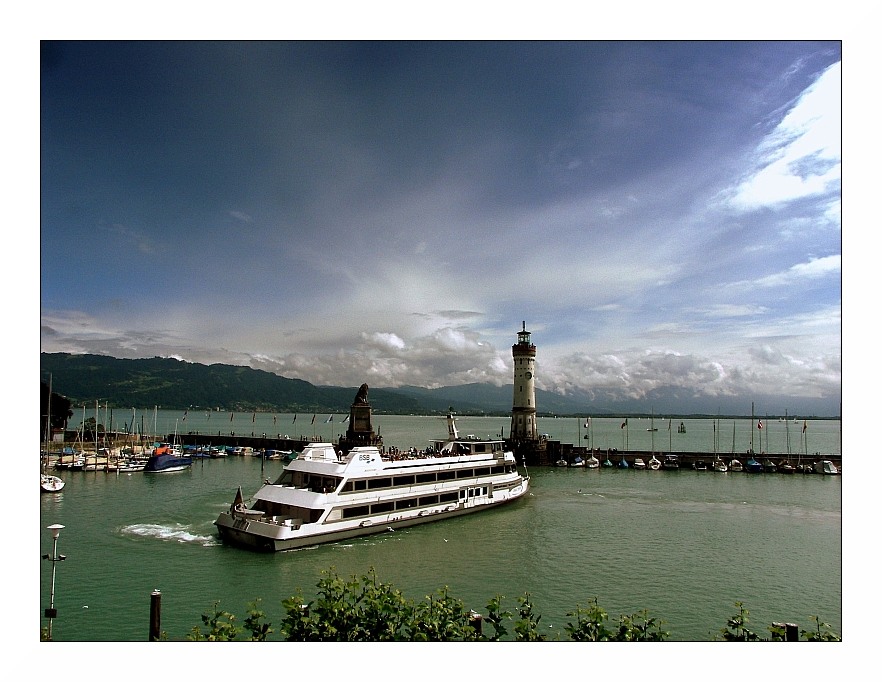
[40,353,838,417]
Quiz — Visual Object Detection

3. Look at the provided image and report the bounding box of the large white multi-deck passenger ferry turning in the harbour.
[214,415,530,551]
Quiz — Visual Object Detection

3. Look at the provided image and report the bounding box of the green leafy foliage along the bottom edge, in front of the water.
[187,567,841,642]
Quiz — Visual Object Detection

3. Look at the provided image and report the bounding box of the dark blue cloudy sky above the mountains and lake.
[39,40,842,414]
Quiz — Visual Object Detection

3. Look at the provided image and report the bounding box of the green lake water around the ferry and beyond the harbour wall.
[34,413,847,642]
